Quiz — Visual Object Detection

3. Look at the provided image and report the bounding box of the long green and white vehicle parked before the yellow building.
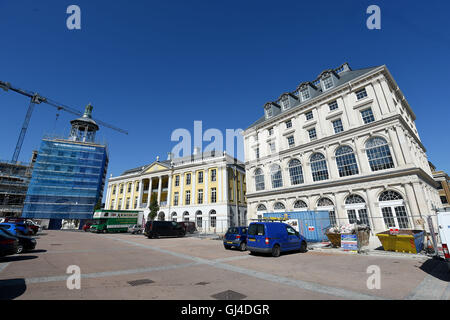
[90,210,143,233]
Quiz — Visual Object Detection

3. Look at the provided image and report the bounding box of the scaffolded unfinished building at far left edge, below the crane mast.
[0,151,37,217]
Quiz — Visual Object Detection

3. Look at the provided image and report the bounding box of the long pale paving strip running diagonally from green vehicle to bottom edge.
[108,237,388,300]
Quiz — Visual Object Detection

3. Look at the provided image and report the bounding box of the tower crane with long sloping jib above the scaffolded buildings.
[0,81,128,162]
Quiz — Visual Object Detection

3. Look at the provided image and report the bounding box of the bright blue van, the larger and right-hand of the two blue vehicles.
[247,222,308,257]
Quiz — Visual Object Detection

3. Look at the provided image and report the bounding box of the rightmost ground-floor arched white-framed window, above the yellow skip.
[378,190,410,229]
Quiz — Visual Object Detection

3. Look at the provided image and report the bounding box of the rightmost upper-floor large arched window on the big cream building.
[366,137,394,171]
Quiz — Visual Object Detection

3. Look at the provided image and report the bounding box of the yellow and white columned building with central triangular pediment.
[105,148,247,233]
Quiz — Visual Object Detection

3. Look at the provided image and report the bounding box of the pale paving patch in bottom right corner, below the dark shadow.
[405,263,450,300]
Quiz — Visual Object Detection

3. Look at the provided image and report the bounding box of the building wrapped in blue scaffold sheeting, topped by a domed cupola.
[22,105,108,229]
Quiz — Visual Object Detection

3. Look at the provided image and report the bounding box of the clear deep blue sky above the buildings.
[0,0,450,182]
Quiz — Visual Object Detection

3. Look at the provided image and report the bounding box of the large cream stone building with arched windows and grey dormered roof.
[243,64,440,232]
